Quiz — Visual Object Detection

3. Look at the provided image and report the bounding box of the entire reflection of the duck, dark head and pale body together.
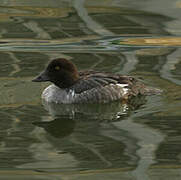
[33,97,146,138]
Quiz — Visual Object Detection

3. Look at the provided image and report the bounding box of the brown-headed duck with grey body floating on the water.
[32,58,161,104]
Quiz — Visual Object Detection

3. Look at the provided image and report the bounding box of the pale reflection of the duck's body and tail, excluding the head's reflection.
[42,96,146,121]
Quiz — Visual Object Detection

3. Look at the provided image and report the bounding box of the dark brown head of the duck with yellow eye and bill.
[32,58,79,88]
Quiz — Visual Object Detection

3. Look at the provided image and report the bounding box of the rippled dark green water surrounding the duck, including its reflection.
[0,0,181,180]
